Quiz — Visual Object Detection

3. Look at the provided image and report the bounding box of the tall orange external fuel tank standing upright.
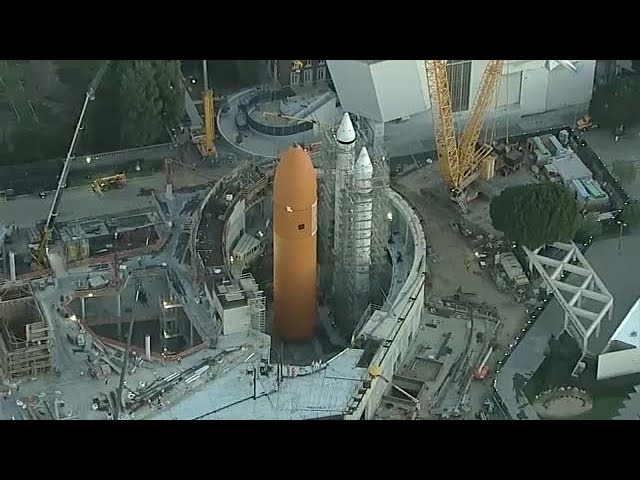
[273,147,318,341]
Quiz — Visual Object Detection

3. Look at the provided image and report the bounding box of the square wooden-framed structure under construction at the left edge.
[0,283,52,382]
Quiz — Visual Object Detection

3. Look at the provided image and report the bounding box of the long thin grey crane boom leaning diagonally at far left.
[33,60,111,268]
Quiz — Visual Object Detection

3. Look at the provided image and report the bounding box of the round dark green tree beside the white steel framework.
[489,182,578,249]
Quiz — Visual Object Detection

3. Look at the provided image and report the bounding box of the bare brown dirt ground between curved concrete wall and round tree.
[393,170,526,414]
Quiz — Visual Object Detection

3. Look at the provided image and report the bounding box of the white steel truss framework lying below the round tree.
[523,242,613,358]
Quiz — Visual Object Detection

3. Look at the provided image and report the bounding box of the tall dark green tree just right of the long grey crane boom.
[119,60,184,147]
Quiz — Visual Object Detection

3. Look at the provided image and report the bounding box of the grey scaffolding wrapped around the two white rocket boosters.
[312,122,390,336]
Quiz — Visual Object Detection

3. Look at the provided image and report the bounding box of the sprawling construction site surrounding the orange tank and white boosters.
[0,61,616,419]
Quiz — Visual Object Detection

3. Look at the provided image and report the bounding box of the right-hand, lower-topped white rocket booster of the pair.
[352,147,373,313]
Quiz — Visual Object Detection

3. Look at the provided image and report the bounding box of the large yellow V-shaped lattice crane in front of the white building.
[425,60,504,202]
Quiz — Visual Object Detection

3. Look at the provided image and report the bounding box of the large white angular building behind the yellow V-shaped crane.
[327,60,596,155]
